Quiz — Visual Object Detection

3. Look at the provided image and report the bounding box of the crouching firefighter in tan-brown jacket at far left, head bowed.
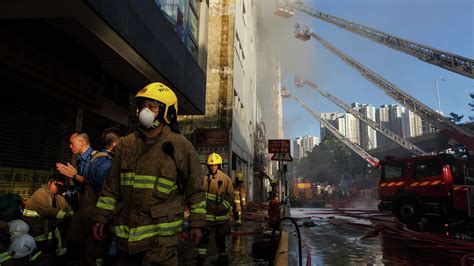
[23,174,74,263]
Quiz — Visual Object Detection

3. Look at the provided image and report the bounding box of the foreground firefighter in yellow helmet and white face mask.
[92,82,206,265]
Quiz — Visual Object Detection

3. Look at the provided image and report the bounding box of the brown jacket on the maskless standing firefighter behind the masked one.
[204,170,234,225]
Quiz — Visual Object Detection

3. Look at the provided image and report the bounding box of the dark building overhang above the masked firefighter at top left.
[0,0,206,114]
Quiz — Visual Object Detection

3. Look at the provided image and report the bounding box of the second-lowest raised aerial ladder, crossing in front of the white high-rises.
[295,77,426,155]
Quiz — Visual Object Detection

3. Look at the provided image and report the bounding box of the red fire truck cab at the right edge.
[378,154,474,224]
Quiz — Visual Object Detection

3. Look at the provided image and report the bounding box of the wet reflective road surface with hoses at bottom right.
[291,209,461,265]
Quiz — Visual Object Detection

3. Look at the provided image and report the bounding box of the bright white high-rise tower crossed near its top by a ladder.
[352,103,377,150]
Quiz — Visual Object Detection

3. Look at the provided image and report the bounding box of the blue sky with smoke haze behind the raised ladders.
[279,0,474,139]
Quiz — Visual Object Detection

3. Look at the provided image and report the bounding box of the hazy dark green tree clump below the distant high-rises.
[296,134,367,184]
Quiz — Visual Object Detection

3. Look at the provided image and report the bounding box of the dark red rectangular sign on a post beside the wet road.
[268,139,293,201]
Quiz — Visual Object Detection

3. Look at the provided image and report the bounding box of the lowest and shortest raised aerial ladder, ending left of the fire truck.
[281,88,379,167]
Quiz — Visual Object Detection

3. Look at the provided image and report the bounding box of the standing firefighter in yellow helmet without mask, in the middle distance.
[197,153,234,265]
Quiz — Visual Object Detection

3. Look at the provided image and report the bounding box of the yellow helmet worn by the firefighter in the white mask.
[135,82,178,124]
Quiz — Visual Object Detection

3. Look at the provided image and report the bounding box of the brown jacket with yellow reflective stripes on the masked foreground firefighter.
[92,125,206,254]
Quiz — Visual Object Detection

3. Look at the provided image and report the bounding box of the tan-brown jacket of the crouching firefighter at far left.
[23,186,72,242]
